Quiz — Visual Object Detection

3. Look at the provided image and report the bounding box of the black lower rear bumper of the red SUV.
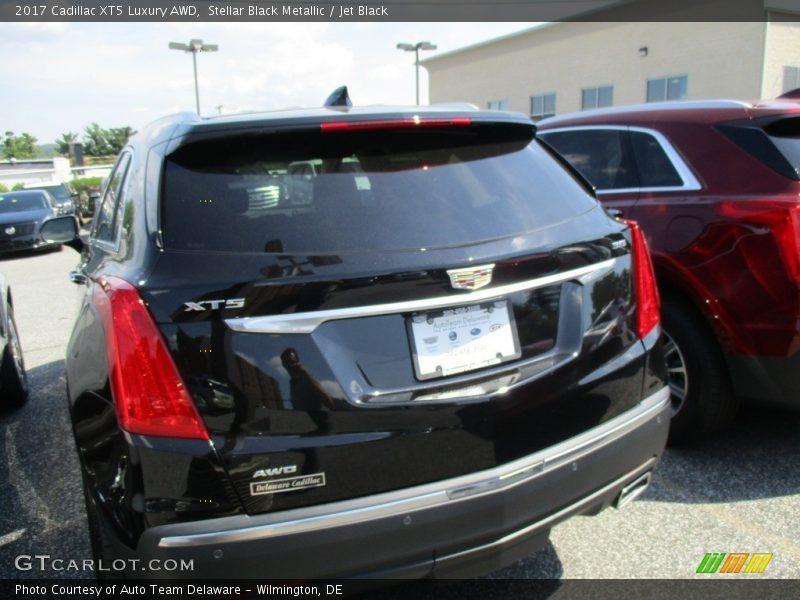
[726,352,800,409]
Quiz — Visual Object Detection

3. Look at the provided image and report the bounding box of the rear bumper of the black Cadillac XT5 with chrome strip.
[130,388,670,579]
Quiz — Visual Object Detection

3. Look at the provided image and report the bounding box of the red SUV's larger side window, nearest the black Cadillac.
[537,129,639,191]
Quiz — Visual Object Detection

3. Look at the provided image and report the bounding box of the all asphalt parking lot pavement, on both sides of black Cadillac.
[0,248,800,584]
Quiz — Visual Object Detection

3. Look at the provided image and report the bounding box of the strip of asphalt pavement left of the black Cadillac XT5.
[0,248,91,578]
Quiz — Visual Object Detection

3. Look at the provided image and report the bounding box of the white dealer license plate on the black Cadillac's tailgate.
[407,300,522,379]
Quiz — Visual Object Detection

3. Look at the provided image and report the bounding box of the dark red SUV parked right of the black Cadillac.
[538,97,800,442]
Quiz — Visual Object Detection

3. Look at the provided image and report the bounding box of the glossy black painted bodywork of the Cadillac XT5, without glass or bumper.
[61,105,663,560]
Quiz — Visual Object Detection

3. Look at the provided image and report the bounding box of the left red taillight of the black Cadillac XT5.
[94,277,209,440]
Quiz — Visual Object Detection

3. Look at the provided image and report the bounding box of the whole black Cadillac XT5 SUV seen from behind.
[46,99,670,578]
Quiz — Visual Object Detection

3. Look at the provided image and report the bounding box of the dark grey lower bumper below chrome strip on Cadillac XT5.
[137,407,669,579]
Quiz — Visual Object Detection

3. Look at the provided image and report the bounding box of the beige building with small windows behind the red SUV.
[420,11,800,119]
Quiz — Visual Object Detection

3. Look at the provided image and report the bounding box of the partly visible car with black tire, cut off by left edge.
[0,273,28,410]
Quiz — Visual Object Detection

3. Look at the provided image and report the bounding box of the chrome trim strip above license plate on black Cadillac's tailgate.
[225,258,616,334]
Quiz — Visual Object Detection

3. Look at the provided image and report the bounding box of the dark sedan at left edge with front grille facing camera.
[0,190,65,254]
